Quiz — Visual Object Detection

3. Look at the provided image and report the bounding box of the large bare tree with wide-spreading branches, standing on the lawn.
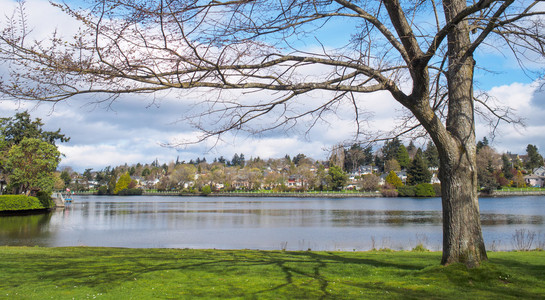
[0,0,545,266]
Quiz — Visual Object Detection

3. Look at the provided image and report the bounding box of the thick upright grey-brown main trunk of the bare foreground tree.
[437,0,487,267]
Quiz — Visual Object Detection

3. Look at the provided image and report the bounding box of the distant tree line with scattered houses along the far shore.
[56,138,543,196]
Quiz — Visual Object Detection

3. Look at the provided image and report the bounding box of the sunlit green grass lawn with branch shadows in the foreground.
[0,247,545,299]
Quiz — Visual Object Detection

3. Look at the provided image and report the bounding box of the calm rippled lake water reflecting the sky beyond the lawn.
[0,196,545,250]
